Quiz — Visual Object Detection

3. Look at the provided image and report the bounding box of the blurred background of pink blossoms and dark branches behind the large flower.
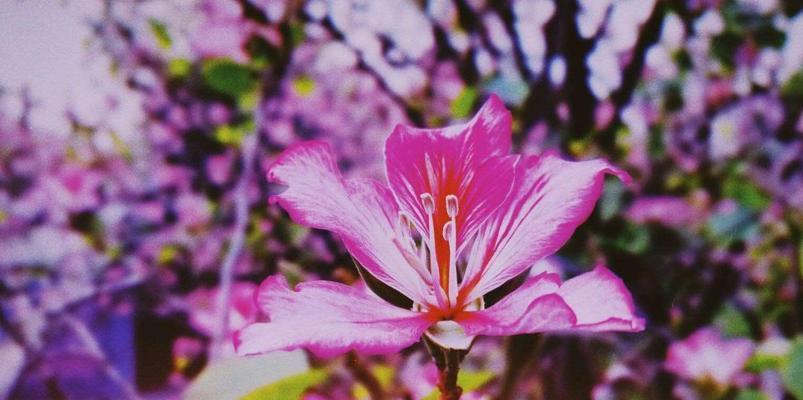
[0,0,803,400]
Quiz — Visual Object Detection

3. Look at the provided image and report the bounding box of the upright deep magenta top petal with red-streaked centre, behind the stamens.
[385,96,513,247]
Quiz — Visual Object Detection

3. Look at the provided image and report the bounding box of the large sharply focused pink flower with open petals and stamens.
[237,96,644,356]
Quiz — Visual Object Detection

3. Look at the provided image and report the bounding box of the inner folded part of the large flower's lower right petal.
[458,273,576,336]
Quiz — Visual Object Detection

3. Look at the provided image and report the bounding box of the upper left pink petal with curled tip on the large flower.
[268,141,428,304]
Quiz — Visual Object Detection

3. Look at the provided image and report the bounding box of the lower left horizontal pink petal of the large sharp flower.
[235,276,433,357]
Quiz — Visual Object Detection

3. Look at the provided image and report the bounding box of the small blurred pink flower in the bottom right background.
[665,327,755,386]
